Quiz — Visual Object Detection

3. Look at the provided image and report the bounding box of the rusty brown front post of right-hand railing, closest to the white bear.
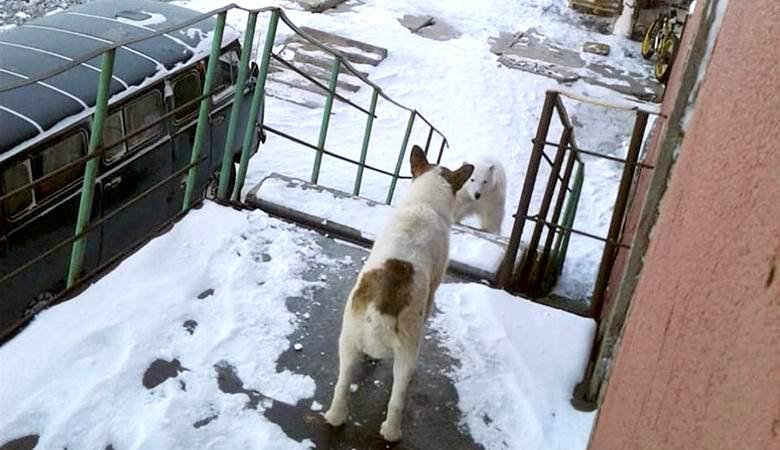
[496,91,557,289]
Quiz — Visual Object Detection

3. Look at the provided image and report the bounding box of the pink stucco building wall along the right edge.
[590,0,780,450]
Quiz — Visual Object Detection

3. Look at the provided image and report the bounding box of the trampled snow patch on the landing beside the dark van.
[0,203,322,449]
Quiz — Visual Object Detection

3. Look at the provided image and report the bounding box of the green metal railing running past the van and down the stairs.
[0,4,448,334]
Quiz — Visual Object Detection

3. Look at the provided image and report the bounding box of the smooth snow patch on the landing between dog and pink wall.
[430,284,596,450]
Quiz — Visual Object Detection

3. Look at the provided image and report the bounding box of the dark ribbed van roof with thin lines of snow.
[0,0,238,162]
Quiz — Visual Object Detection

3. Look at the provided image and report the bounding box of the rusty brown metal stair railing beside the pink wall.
[497,91,658,320]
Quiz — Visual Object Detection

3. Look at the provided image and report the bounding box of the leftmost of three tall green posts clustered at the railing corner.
[181,11,227,211]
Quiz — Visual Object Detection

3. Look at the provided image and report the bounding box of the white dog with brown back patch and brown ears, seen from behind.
[325,145,474,441]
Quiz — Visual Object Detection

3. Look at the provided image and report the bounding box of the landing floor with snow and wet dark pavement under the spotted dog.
[0,202,595,450]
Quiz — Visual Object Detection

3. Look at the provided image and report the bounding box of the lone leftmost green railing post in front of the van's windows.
[68,49,116,287]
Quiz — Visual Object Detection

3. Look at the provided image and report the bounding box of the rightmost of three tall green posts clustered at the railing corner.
[230,9,279,202]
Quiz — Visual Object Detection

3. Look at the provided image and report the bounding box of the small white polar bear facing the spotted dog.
[455,156,506,234]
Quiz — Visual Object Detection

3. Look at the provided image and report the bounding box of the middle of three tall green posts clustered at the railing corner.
[217,11,257,200]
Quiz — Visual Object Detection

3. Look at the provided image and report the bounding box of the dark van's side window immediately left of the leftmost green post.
[33,131,87,203]
